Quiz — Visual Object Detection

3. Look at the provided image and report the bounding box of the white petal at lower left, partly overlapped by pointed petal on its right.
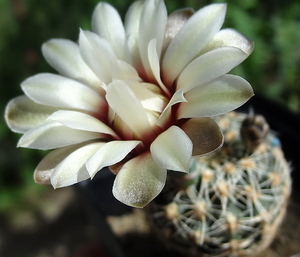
[51,143,102,188]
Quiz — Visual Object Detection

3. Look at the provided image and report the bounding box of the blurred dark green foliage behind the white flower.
[0,0,300,213]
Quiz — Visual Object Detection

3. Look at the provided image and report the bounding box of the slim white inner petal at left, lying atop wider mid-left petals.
[48,111,117,137]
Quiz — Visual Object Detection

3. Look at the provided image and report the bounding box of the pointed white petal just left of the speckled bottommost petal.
[86,141,140,178]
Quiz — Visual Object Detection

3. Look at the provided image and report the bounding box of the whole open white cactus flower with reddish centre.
[5,0,253,207]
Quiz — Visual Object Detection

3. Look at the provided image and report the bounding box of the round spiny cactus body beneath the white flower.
[147,112,291,256]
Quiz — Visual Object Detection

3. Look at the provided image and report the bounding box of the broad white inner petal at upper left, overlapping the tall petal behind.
[79,30,117,84]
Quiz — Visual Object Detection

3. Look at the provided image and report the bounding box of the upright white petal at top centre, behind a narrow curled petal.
[139,0,168,80]
